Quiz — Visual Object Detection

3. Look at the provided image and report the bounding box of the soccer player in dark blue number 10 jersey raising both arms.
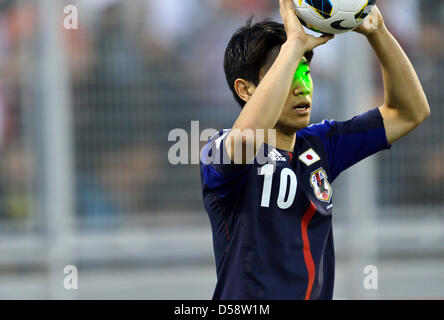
[200,0,430,300]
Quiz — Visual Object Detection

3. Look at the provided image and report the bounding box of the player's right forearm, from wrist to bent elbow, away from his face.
[368,26,430,123]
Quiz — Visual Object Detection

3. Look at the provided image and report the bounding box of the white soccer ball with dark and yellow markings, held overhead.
[293,0,376,34]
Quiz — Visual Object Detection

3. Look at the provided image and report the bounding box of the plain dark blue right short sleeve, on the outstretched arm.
[305,108,391,181]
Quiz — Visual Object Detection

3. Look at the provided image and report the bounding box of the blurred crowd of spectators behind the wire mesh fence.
[0,0,444,223]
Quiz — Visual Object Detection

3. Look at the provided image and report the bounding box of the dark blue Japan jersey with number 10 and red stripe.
[200,109,390,300]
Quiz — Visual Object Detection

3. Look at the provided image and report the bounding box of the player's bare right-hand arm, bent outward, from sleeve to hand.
[356,7,430,144]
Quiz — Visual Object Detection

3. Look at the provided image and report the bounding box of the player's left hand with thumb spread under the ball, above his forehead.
[279,0,334,51]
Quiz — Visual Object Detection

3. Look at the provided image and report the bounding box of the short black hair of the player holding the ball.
[224,17,313,107]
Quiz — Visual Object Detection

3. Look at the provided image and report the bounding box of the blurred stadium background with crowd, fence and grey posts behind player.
[0,0,444,299]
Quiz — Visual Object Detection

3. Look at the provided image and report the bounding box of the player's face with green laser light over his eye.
[277,58,313,131]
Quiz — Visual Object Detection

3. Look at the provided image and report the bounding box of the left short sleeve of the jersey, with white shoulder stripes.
[200,130,251,198]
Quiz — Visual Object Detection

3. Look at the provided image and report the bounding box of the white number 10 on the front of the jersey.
[260,164,298,209]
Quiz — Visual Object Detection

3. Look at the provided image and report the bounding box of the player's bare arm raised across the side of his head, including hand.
[225,0,331,164]
